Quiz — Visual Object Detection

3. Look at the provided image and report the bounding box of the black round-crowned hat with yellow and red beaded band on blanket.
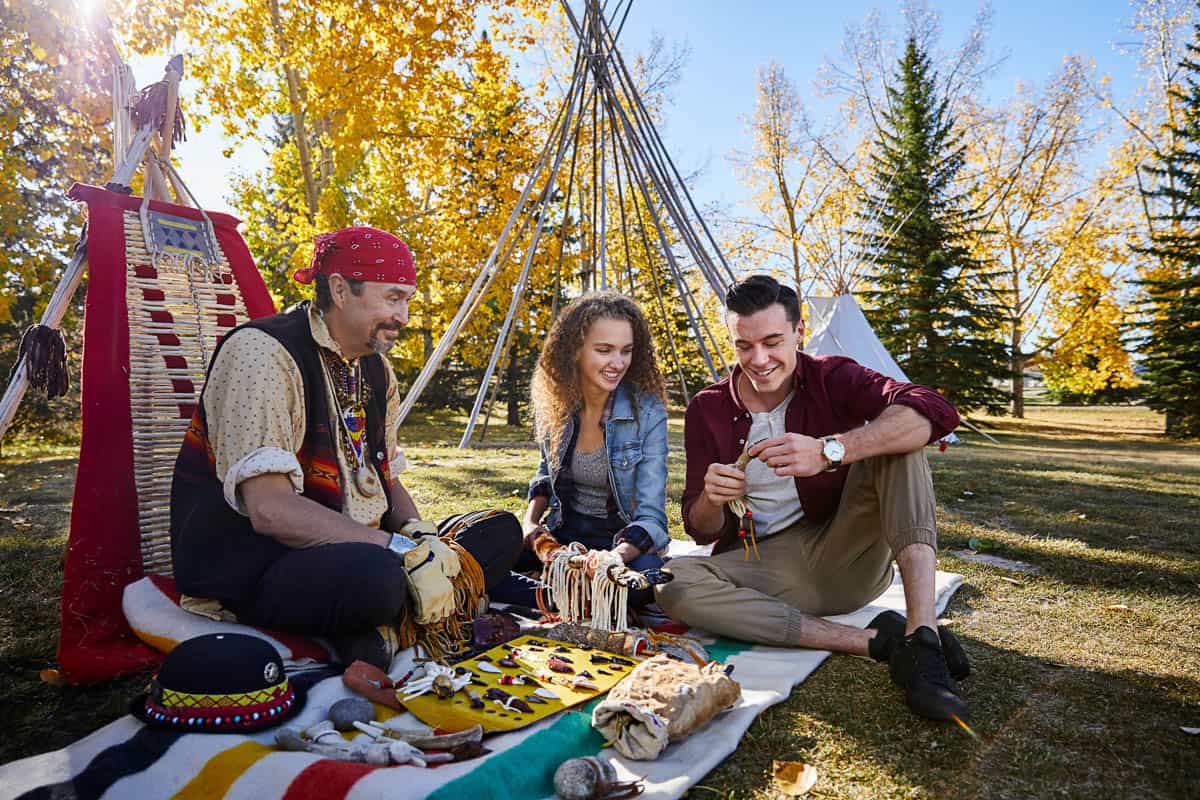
[130,633,305,733]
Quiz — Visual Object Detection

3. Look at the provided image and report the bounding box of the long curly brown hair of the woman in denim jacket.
[529,291,666,459]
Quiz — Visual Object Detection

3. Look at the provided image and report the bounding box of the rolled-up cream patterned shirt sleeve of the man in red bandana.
[204,329,307,515]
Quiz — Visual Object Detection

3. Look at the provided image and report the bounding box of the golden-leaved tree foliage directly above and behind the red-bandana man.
[113,0,548,419]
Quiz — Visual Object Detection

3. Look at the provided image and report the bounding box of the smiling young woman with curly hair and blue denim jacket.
[497,291,670,607]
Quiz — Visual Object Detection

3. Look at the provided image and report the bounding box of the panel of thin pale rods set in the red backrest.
[125,211,250,576]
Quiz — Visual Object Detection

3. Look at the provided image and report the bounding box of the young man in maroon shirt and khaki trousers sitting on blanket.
[658,276,968,720]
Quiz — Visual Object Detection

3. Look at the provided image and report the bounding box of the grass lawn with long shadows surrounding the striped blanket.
[0,407,1200,798]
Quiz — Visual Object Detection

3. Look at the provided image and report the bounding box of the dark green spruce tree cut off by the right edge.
[1140,24,1200,438]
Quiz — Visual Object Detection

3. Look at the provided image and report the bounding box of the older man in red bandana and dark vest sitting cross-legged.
[170,228,521,668]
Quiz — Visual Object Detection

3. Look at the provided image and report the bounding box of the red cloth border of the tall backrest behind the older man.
[58,184,275,684]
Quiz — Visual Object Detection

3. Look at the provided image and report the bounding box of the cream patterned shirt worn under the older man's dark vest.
[204,306,404,528]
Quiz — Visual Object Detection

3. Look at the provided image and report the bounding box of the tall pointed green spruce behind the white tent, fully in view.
[862,38,1007,411]
